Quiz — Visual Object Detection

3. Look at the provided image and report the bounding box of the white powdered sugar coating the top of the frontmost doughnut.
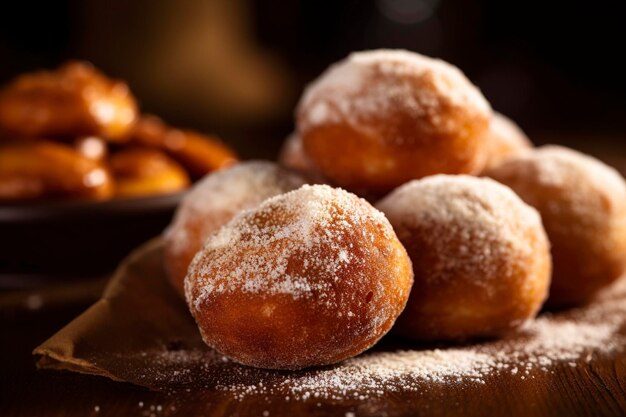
[186,185,394,308]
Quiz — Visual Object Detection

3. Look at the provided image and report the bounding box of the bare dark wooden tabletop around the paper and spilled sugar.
[0,272,626,417]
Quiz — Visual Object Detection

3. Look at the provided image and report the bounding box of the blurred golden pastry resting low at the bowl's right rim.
[109,148,190,197]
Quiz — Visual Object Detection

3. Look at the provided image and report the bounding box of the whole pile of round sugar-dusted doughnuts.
[165,50,626,369]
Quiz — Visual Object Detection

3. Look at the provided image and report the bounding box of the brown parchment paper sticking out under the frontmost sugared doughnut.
[33,239,338,392]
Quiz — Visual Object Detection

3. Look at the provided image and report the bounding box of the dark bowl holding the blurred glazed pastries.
[0,193,183,288]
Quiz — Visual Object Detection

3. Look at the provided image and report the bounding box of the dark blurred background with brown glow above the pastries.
[0,0,626,159]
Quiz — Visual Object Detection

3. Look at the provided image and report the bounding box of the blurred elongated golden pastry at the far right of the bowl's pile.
[133,116,237,178]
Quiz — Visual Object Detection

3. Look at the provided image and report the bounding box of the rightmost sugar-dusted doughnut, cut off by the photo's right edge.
[486,146,626,307]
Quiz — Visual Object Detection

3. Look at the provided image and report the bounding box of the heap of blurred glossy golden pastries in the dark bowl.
[0,62,236,201]
